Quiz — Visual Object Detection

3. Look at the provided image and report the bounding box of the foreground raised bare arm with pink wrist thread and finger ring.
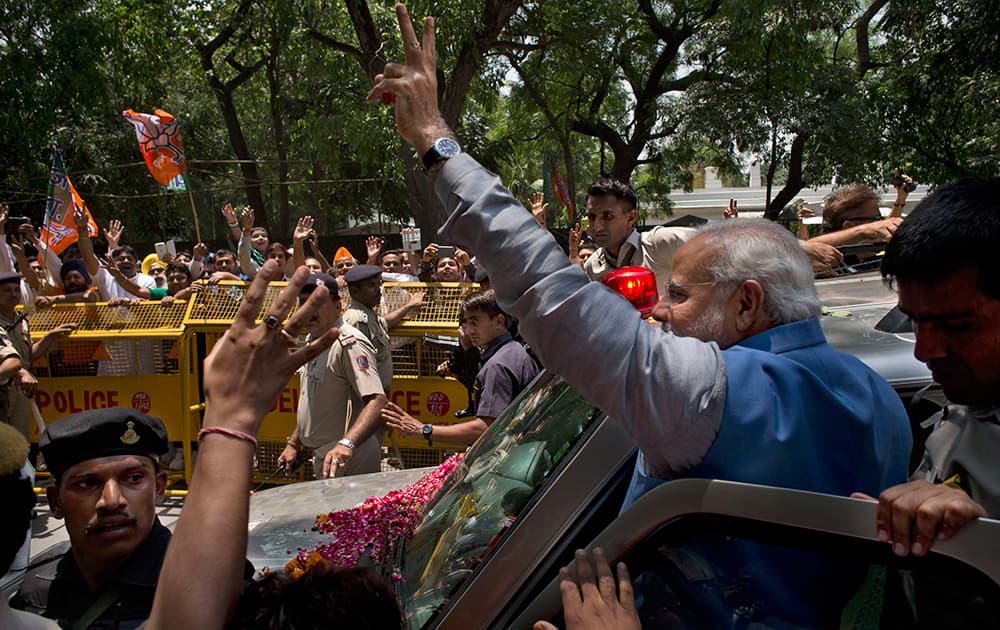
[147,261,337,629]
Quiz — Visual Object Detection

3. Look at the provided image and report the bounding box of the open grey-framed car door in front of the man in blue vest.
[509,479,1000,628]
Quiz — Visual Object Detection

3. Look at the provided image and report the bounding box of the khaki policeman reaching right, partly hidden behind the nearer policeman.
[344,265,424,395]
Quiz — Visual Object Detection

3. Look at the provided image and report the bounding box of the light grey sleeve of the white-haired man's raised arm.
[436,155,726,475]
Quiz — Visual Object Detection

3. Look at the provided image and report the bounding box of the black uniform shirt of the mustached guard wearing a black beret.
[12,519,170,629]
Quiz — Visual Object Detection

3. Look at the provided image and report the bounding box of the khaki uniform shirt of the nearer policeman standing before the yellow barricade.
[297,326,385,472]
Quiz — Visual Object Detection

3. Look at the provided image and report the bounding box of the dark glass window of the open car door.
[623,515,1000,628]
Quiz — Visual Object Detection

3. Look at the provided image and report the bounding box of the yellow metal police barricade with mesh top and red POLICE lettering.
[25,282,477,483]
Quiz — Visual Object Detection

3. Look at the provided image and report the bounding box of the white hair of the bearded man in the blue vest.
[698,219,821,326]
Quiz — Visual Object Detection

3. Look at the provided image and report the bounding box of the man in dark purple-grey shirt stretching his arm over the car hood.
[382,291,538,446]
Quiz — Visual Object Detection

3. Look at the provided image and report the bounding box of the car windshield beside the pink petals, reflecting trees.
[400,373,601,628]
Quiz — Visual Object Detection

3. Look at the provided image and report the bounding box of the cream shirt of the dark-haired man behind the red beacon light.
[583,225,697,287]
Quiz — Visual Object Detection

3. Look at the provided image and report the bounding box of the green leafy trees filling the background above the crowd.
[0,0,1000,241]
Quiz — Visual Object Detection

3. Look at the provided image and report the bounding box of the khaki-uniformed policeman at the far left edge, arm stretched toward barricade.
[0,273,76,438]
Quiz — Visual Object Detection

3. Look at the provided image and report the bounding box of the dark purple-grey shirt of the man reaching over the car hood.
[474,332,538,418]
